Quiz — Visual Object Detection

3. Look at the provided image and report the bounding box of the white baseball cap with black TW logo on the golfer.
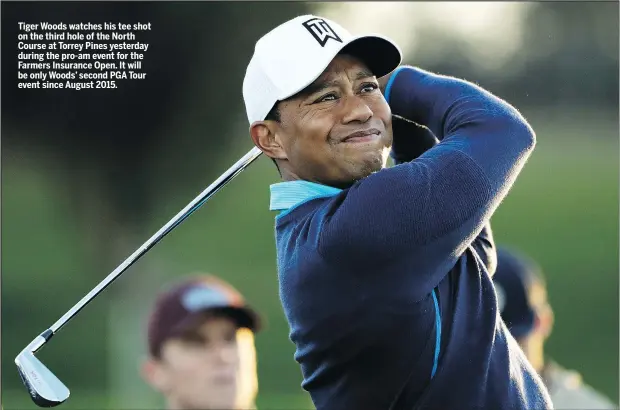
[243,15,402,124]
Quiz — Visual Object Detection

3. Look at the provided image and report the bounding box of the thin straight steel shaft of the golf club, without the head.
[49,147,262,334]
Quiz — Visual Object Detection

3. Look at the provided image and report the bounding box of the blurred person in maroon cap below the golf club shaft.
[141,275,260,410]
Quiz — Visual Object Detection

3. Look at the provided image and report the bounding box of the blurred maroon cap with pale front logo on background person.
[148,275,260,357]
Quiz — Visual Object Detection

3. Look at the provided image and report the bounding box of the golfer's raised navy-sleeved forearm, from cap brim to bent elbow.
[382,66,535,194]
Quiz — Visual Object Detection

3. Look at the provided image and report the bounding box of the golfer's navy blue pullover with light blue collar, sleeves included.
[271,66,552,410]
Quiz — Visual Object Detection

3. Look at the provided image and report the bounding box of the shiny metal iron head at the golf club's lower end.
[15,339,69,407]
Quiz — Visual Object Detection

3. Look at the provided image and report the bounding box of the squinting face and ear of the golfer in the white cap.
[251,55,392,187]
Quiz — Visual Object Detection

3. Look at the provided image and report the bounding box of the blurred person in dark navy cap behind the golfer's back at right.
[493,247,618,409]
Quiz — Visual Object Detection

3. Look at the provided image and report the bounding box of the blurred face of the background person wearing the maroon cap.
[144,317,257,409]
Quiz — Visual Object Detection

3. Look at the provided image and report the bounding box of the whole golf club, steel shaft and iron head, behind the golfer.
[15,147,262,407]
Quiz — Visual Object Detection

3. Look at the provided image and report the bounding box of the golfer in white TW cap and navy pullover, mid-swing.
[243,16,552,410]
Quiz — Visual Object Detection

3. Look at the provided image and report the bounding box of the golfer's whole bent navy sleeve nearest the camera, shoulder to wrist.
[318,67,535,292]
